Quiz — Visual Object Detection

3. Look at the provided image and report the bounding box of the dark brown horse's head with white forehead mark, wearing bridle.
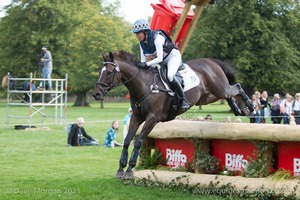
[93,52,121,100]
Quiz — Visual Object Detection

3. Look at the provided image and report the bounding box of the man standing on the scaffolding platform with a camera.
[41,47,53,90]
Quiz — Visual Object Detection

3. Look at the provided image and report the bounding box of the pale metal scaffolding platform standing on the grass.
[7,73,68,128]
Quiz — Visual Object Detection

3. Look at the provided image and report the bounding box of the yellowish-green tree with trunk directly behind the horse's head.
[64,1,133,106]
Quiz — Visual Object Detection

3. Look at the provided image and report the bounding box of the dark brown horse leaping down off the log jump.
[92,50,253,179]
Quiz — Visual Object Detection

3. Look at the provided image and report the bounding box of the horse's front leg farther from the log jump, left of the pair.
[116,115,141,178]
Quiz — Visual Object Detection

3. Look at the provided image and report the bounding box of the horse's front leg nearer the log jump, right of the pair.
[124,117,157,179]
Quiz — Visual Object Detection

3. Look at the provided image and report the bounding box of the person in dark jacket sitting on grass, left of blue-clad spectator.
[68,117,98,147]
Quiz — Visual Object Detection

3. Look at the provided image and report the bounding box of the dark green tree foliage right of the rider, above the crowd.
[184,0,300,93]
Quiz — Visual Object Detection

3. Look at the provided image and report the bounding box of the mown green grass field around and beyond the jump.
[0,103,251,200]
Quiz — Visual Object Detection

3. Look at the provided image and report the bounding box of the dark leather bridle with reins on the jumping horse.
[96,62,141,95]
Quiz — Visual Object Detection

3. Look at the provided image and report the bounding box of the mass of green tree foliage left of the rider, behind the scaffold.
[0,0,134,106]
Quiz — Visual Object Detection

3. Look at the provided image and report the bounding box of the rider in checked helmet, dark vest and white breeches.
[131,19,190,111]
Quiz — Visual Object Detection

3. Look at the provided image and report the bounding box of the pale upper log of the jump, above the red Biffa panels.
[142,120,300,142]
